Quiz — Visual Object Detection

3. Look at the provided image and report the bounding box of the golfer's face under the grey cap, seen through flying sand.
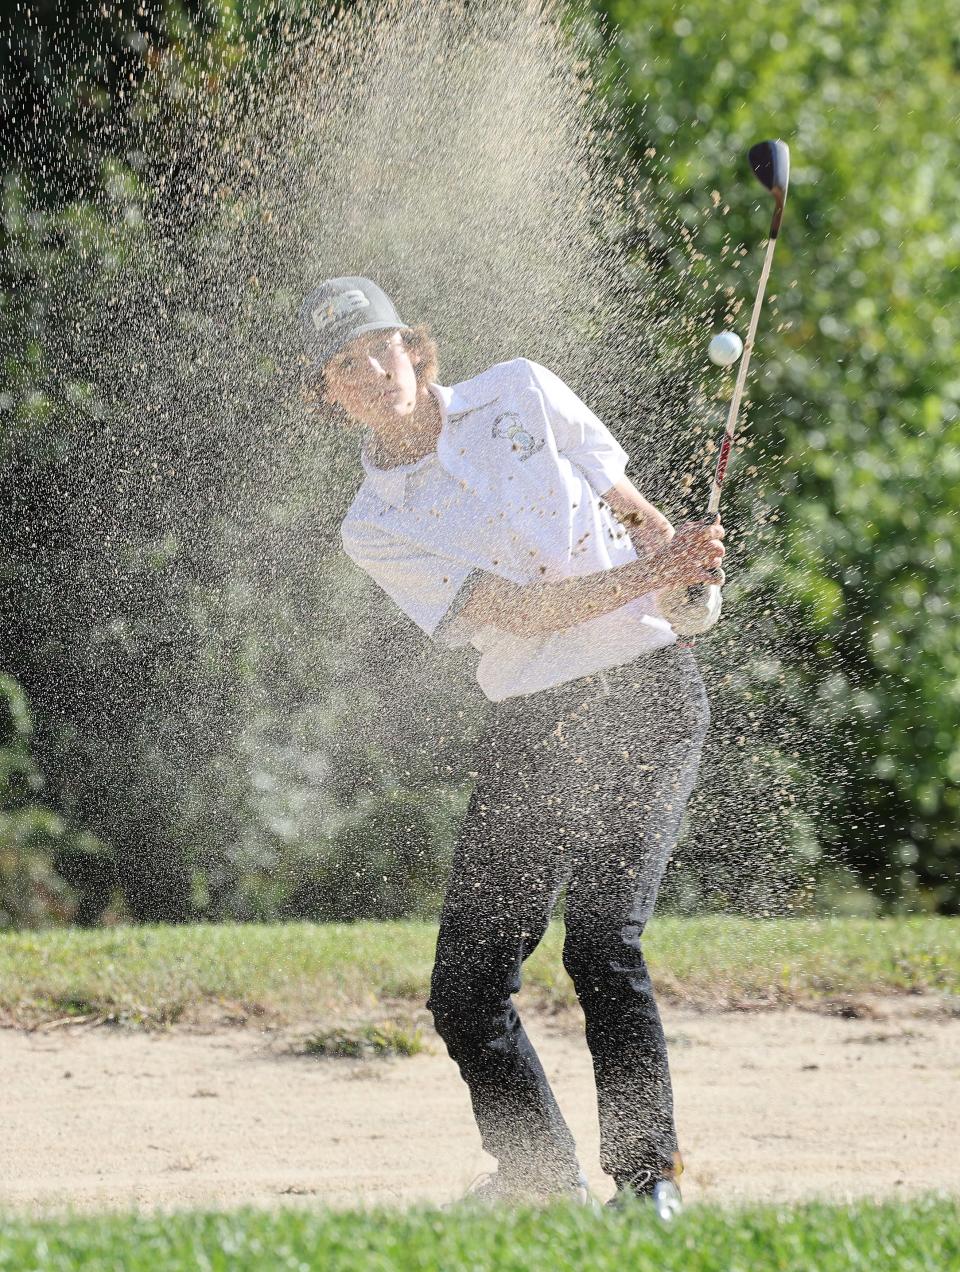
[324,331,417,427]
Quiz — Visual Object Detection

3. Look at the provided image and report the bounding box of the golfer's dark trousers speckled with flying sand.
[427,646,708,1192]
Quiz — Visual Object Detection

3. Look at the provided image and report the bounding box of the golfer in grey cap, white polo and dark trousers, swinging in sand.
[303,277,723,1213]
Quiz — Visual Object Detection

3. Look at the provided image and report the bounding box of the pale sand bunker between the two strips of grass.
[0,1000,960,1210]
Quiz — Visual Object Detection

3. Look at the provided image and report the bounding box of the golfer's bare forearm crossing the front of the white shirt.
[459,557,668,636]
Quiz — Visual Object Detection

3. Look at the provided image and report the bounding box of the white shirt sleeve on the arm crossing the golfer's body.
[341,522,478,649]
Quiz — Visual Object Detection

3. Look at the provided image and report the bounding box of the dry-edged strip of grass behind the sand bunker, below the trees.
[0,917,960,1027]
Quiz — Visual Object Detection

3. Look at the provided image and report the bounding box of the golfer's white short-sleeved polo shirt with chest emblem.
[342,357,676,702]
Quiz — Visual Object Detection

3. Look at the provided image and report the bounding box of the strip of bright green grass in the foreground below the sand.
[0,1198,960,1272]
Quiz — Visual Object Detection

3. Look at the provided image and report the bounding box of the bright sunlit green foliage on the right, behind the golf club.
[594,0,960,911]
